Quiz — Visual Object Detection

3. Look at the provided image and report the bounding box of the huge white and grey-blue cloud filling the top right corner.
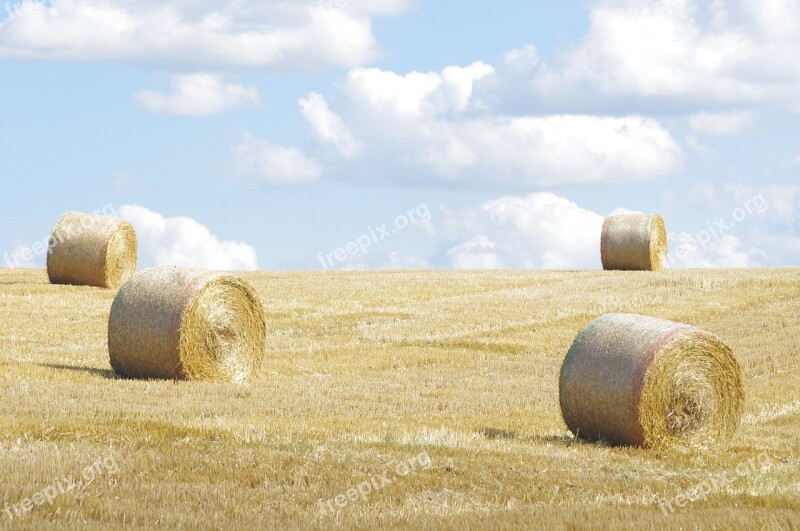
[489,0,800,112]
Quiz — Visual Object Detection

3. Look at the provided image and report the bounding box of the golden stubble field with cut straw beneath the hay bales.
[0,268,800,529]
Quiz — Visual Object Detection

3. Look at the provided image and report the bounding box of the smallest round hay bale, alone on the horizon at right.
[600,214,667,271]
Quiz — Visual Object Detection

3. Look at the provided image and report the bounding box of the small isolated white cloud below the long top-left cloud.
[135,72,259,116]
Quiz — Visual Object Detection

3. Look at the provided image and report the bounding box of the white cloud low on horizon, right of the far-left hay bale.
[118,205,258,271]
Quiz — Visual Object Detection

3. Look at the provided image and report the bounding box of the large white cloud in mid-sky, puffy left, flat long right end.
[284,62,683,188]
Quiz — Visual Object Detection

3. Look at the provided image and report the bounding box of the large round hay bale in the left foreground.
[108,267,267,383]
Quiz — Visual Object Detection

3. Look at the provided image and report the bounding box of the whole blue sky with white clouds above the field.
[0,0,800,270]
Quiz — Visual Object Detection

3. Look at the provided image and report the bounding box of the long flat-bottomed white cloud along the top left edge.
[0,0,407,68]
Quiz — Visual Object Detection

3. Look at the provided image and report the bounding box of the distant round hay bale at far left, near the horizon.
[47,212,137,289]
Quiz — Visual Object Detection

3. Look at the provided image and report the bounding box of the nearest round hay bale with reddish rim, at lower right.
[559,314,744,448]
